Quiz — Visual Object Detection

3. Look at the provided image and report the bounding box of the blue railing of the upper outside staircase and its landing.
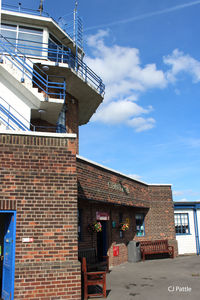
[0,34,66,100]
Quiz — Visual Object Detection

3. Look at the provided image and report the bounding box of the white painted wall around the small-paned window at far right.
[174,209,196,254]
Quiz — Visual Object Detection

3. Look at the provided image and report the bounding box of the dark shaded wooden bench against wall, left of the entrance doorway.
[78,248,109,273]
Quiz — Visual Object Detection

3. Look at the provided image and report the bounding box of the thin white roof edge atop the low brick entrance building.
[76,155,172,186]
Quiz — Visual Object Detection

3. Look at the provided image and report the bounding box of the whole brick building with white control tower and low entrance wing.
[0,4,176,300]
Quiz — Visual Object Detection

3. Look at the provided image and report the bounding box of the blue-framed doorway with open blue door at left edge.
[0,211,16,300]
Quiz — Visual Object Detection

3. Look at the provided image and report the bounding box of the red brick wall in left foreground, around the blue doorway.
[0,135,81,300]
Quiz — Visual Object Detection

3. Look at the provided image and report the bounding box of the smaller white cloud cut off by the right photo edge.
[163,49,200,82]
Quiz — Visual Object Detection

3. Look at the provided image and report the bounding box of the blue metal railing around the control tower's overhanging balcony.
[0,38,105,96]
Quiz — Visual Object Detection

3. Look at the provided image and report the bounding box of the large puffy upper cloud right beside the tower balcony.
[86,30,167,102]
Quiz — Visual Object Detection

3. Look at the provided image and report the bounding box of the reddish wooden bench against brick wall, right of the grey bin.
[140,240,174,261]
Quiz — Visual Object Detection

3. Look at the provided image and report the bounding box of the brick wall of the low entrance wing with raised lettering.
[77,158,177,265]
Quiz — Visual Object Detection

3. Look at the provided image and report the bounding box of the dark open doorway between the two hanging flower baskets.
[97,221,108,261]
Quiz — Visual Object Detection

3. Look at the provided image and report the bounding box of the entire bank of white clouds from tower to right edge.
[86,30,200,132]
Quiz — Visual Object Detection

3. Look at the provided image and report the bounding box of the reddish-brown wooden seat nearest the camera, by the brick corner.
[82,257,106,300]
